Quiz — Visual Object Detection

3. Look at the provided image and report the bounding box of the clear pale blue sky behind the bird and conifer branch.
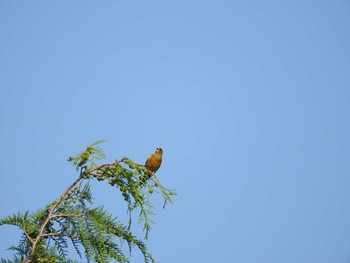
[0,0,350,263]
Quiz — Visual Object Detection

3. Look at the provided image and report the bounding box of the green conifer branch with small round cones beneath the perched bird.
[0,141,176,263]
